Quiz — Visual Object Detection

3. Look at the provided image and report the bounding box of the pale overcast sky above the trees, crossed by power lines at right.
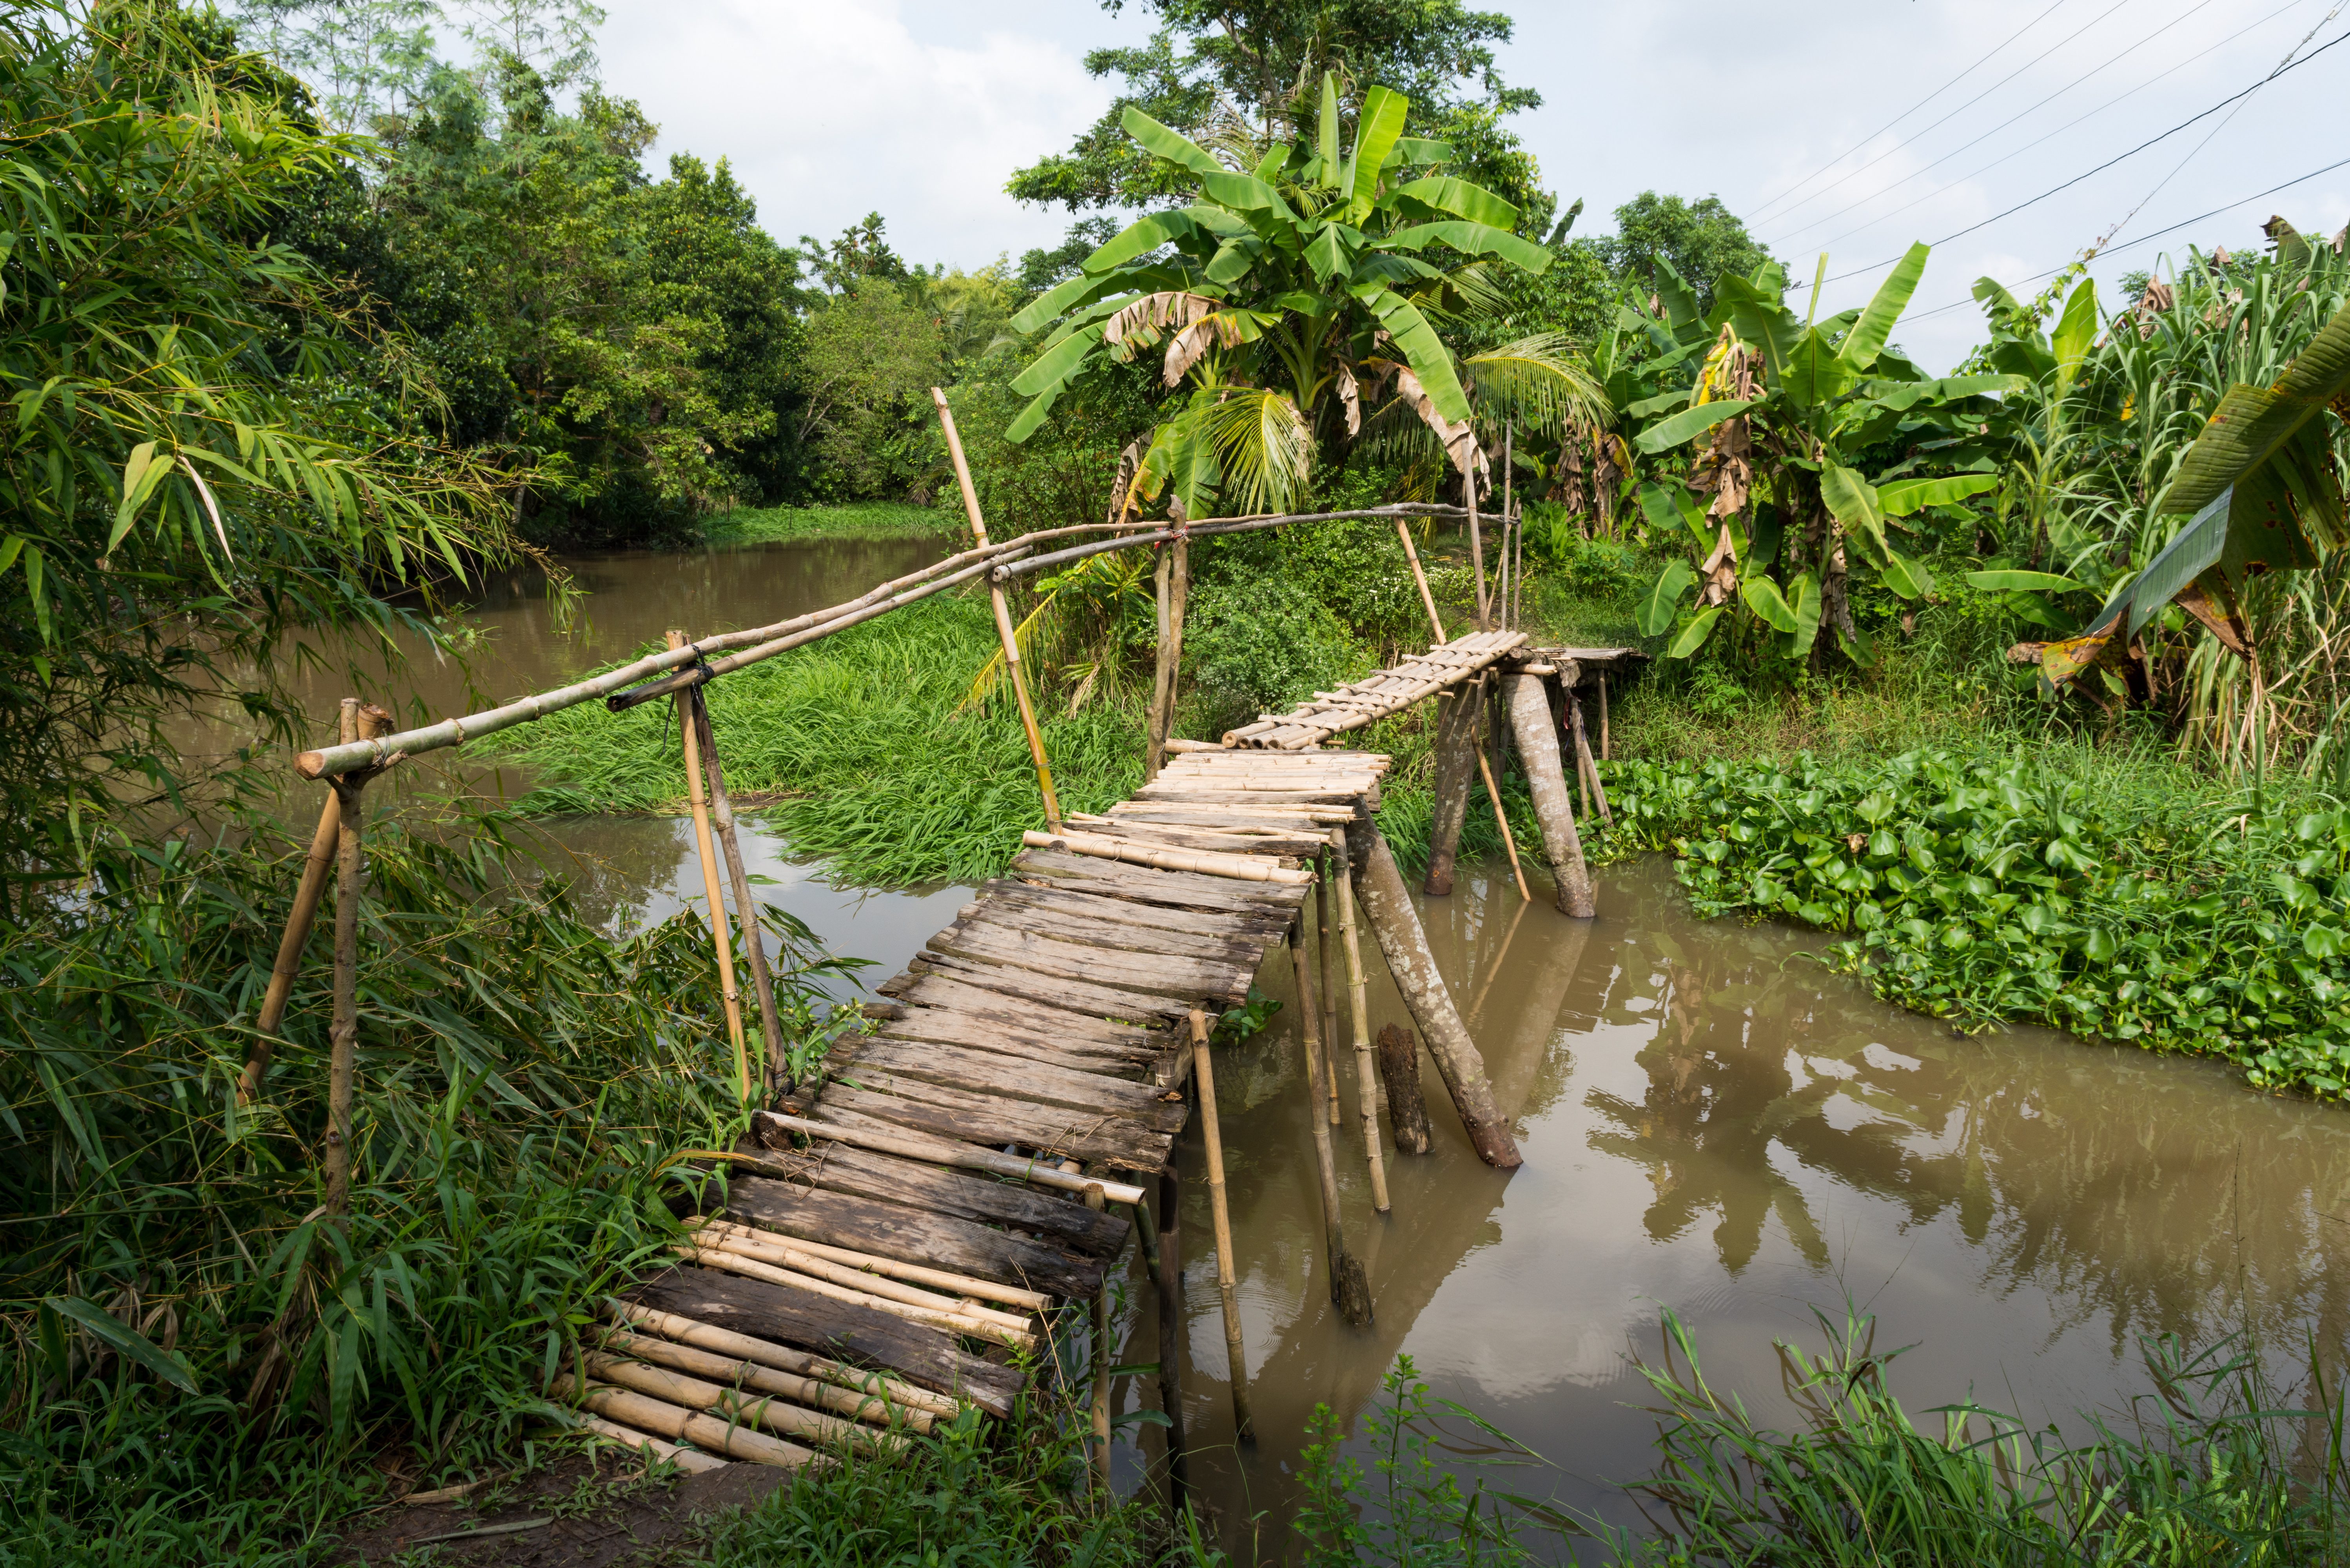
[602,0,2350,369]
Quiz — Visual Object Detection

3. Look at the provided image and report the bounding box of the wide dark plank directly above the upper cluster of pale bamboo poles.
[726,1176,1107,1298]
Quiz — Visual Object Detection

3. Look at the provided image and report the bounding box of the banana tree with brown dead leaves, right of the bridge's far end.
[1626,245,2023,668]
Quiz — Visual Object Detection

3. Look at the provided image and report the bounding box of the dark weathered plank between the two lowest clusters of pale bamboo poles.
[628,1267,1022,1415]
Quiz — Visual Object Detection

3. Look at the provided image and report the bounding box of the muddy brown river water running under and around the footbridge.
[234,541,2350,1554]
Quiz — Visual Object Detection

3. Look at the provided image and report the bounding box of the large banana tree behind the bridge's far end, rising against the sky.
[1006,75,1551,517]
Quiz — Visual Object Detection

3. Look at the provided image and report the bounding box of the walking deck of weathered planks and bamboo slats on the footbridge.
[585,677,1521,1465]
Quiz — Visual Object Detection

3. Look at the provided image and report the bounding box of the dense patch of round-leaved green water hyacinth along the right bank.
[1605,752,2350,1098]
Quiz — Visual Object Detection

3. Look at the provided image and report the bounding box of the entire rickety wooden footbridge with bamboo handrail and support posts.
[247,392,1640,1497]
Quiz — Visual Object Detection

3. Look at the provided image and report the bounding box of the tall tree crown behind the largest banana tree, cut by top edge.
[1006,0,1549,223]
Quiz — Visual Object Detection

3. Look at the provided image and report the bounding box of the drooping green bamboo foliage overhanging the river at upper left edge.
[0,0,515,846]
